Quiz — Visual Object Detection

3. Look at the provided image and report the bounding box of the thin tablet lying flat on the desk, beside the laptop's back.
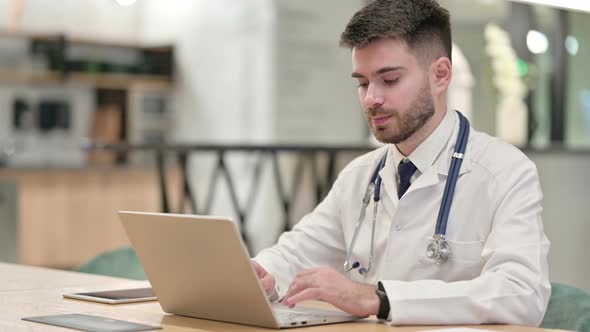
[64,287,157,304]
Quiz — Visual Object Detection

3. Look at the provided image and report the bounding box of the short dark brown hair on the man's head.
[340,0,452,64]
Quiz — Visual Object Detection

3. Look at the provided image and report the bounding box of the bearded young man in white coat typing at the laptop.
[254,0,550,326]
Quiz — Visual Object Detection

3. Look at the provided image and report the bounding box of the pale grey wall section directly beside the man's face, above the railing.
[274,0,368,144]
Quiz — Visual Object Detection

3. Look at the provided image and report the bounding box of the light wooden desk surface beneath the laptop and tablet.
[0,263,564,332]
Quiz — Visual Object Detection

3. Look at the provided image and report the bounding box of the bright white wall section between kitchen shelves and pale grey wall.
[140,0,274,142]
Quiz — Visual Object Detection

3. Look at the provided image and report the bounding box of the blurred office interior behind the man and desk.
[0,0,590,290]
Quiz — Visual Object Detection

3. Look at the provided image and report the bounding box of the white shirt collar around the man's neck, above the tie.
[390,111,457,174]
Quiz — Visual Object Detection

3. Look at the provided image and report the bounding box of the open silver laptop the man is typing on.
[119,212,358,328]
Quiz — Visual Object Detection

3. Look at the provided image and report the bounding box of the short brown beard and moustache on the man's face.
[366,84,434,144]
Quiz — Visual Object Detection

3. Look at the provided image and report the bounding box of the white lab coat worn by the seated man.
[255,112,551,326]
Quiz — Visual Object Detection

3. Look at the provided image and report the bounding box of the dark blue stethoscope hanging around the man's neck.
[344,112,469,276]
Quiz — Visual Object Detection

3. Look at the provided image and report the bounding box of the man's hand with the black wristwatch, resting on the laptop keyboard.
[282,267,379,317]
